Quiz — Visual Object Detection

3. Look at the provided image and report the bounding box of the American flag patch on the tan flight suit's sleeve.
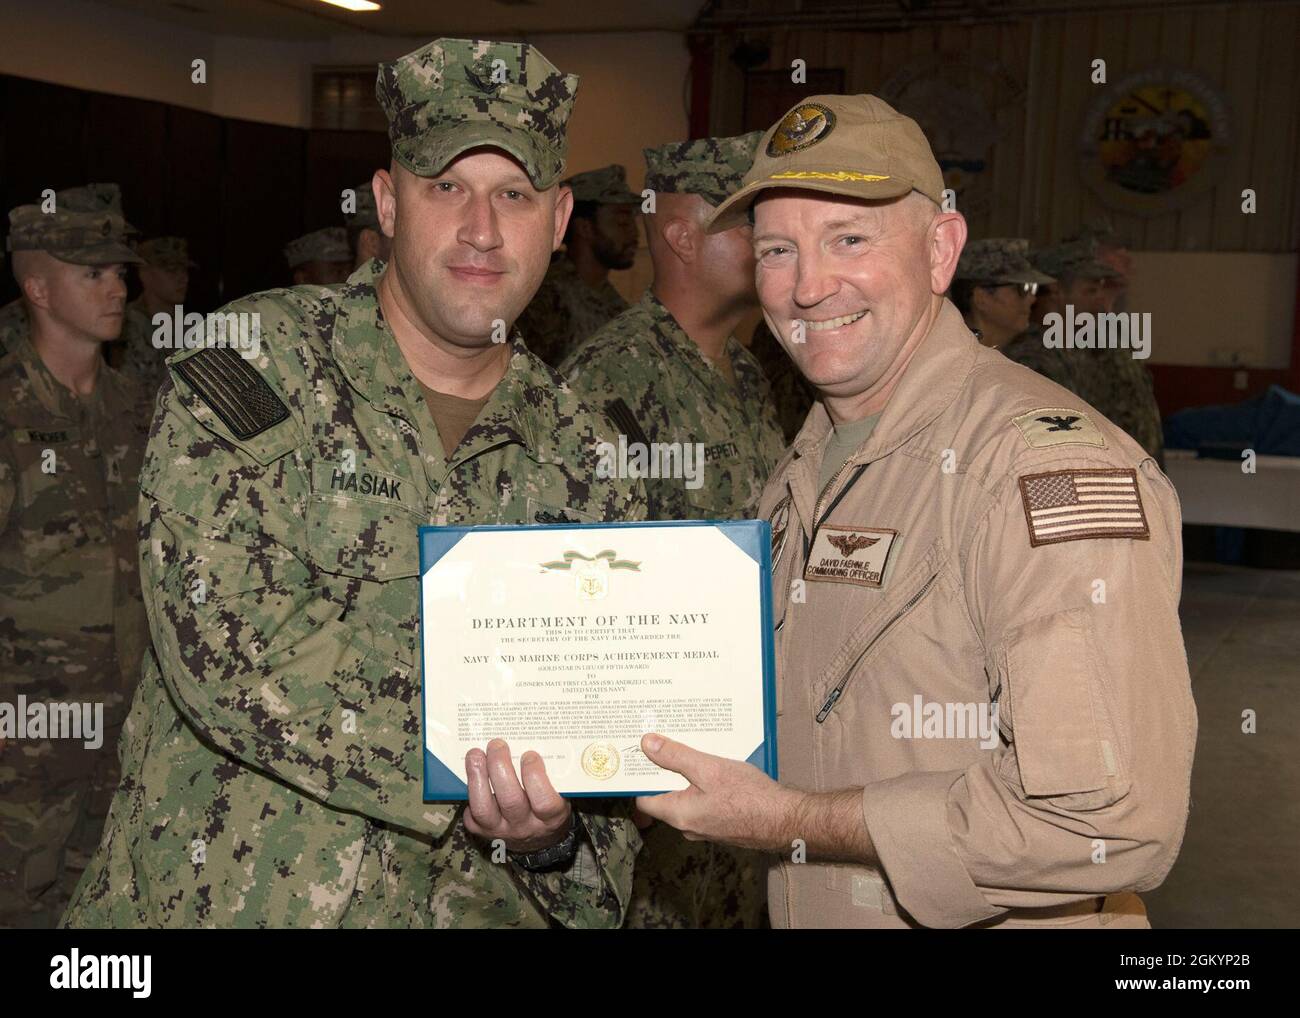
[1021,469,1151,547]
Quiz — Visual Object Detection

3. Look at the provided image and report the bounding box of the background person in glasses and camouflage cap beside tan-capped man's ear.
[949,237,1053,350]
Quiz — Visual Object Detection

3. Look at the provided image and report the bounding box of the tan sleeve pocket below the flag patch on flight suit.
[1005,608,1126,810]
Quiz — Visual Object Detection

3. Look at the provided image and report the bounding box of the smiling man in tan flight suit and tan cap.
[638,95,1196,928]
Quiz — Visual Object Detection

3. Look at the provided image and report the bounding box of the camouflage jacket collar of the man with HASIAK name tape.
[332,259,558,460]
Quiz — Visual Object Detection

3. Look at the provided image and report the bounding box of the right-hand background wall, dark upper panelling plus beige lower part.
[692,3,1300,413]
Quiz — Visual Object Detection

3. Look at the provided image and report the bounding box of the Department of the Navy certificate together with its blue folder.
[420,520,776,801]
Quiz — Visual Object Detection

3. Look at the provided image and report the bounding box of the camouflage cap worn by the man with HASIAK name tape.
[374,39,577,191]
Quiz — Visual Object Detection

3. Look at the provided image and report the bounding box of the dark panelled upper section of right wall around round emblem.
[709,3,1300,252]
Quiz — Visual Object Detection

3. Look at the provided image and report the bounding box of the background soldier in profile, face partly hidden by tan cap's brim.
[562,131,785,928]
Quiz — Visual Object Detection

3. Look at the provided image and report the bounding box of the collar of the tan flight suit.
[793,298,979,463]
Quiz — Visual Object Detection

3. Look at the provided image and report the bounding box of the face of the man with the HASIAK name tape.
[380,148,572,348]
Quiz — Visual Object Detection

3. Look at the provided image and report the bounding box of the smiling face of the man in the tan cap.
[754,189,965,399]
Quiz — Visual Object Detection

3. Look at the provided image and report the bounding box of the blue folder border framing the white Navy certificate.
[420,520,777,802]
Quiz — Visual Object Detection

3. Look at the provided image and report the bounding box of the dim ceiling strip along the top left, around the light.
[98,0,703,40]
